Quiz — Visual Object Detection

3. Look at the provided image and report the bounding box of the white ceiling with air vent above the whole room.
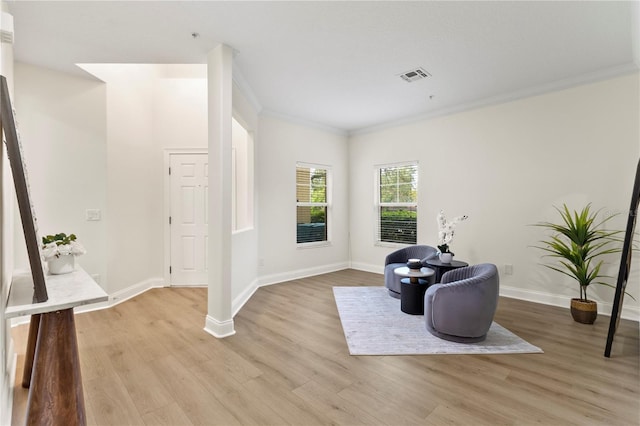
[6,0,639,132]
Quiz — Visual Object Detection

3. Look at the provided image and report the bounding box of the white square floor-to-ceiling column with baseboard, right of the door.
[204,45,235,337]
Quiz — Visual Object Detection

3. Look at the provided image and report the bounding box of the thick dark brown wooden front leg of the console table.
[26,308,86,426]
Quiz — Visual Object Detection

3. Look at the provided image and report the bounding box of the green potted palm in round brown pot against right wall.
[535,203,622,324]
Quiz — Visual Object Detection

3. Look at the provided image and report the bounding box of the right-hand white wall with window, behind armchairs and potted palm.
[349,74,640,319]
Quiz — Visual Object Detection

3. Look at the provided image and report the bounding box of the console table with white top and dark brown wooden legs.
[5,268,108,425]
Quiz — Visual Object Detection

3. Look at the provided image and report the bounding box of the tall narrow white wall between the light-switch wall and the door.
[107,72,158,294]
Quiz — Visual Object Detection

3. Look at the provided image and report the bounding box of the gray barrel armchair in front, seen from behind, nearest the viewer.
[424,263,500,343]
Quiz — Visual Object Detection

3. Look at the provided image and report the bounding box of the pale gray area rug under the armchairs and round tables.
[333,287,542,355]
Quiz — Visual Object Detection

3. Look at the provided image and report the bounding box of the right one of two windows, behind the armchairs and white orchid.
[376,162,418,244]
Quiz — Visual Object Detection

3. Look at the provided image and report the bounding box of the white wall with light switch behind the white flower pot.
[14,63,107,283]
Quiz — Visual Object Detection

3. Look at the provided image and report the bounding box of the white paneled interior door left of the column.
[170,153,209,286]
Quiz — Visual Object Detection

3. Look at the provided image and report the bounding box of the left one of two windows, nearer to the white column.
[296,163,331,245]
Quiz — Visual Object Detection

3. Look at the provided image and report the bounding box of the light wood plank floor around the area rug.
[13,270,640,425]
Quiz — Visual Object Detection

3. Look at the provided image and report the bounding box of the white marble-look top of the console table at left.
[5,266,109,318]
